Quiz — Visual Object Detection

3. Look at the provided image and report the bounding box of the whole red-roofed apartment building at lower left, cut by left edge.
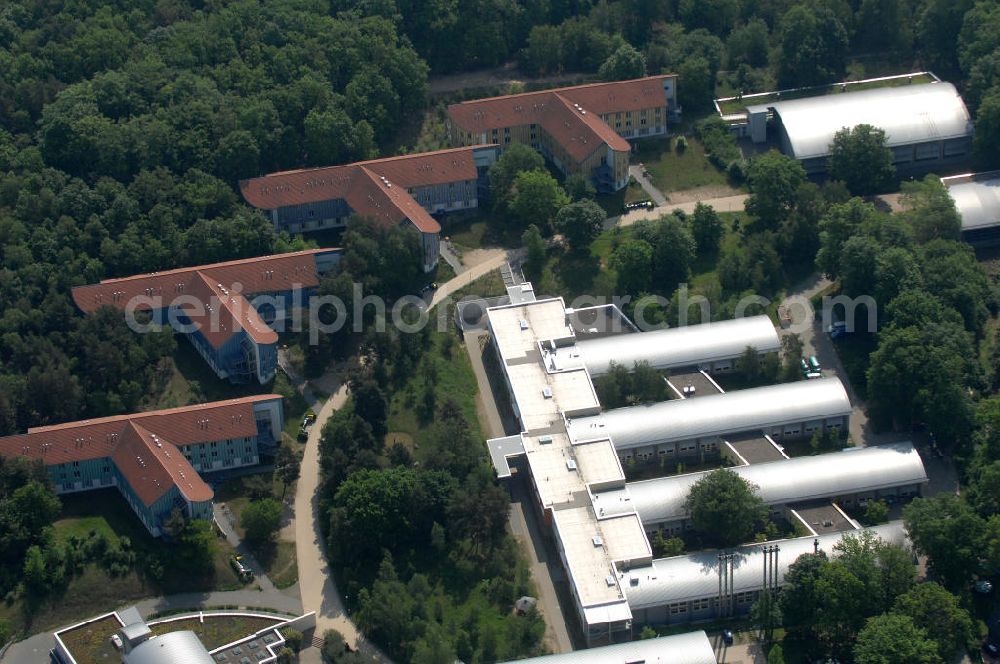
[0,394,284,537]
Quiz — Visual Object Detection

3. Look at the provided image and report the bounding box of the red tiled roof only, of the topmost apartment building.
[448,74,673,161]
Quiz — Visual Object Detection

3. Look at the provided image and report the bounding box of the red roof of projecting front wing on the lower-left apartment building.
[111,422,214,506]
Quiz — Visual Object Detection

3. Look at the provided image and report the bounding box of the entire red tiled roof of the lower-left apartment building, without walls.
[0,394,281,505]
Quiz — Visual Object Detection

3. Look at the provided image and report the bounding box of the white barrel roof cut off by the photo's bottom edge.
[494,631,718,664]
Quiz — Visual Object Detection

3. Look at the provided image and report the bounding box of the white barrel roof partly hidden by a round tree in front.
[594,442,927,526]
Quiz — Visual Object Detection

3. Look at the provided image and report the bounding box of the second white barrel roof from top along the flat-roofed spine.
[568,378,851,450]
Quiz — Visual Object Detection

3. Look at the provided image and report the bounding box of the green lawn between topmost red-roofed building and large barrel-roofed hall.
[632,136,729,193]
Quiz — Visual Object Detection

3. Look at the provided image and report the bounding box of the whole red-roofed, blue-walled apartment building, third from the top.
[73,249,340,384]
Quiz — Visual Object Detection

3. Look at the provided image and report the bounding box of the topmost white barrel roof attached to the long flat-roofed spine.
[576,316,781,376]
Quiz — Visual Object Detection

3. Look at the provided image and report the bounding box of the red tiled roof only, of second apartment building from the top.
[240,147,476,218]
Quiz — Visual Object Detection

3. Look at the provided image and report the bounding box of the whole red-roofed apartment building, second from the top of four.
[240,145,499,272]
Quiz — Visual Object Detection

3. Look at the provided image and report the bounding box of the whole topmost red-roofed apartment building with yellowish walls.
[448,74,680,192]
